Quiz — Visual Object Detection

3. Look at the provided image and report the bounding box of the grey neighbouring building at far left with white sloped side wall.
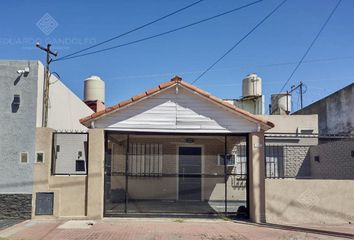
[0,60,93,218]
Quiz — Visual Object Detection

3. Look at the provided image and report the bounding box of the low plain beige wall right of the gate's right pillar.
[266,179,354,224]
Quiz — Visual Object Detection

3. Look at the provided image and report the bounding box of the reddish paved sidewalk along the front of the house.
[0,218,354,240]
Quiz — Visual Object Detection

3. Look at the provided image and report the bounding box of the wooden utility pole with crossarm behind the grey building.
[36,43,58,127]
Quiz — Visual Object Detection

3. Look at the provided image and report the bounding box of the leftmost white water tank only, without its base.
[84,76,105,103]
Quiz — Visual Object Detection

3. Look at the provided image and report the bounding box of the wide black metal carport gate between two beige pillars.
[104,132,248,218]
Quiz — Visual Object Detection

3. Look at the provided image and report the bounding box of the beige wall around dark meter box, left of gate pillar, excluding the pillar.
[32,128,86,218]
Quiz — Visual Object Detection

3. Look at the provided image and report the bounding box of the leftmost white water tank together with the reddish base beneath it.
[84,76,105,112]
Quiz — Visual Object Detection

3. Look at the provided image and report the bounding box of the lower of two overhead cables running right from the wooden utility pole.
[53,0,264,61]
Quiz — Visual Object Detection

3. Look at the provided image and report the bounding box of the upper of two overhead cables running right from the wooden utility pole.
[57,0,205,60]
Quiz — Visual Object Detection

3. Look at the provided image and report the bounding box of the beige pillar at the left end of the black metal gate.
[87,129,104,219]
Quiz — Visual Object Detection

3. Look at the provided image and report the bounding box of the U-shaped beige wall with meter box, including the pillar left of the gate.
[32,128,104,219]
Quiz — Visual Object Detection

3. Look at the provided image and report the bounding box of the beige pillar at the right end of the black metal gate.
[249,131,265,223]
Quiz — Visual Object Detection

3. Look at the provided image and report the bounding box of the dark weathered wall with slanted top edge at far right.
[293,83,354,135]
